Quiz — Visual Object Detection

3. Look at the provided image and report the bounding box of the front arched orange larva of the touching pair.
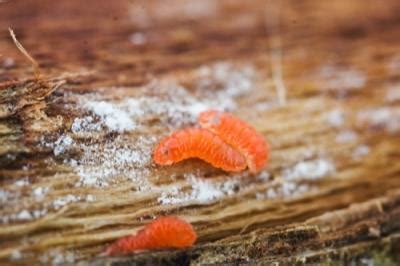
[153,128,246,172]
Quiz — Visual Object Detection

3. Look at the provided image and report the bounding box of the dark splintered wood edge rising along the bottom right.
[83,190,400,266]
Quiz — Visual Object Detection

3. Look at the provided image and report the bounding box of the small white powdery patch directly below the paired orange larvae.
[158,176,239,205]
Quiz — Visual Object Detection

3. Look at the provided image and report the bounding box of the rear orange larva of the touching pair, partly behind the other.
[199,110,269,173]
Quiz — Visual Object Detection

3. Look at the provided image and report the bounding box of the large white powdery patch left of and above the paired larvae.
[42,62,255,189]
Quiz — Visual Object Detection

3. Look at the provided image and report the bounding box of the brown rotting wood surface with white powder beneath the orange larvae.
[0,0,400,265]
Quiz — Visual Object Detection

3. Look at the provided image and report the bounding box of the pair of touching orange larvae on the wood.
[153,110,269,173]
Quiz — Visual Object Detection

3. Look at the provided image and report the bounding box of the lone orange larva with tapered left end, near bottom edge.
[104,216,197,256]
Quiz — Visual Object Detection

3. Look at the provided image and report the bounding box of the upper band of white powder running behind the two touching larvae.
[71,62,256,133]
